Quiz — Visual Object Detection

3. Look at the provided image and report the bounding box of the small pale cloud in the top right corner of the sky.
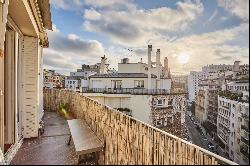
[218,0,249,21]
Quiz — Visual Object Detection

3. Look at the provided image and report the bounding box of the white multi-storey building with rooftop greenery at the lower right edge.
[217,81,249,164]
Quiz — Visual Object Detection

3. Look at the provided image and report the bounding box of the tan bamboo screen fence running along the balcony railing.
[44,89,235,165]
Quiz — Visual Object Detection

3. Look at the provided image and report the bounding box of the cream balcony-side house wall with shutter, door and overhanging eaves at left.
[0,0,52,163]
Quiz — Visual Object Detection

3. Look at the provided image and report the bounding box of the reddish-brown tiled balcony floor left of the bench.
[11,112,94,165]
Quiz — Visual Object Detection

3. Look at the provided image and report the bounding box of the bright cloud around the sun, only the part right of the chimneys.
[162,24,249,72]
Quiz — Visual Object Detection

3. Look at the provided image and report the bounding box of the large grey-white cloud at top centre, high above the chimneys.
[83,1,203,46]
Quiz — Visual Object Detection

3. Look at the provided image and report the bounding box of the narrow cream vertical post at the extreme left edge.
[0,0,9,150]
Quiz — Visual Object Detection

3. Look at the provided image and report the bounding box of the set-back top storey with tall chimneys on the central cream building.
[89,45,171,92]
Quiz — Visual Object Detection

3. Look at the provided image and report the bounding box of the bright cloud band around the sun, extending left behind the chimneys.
[102,24,249,74]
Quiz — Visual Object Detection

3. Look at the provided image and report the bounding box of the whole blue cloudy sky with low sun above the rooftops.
[44,0,249,74]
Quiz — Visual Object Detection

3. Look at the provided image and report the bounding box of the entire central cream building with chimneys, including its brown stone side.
[83,45,187,137]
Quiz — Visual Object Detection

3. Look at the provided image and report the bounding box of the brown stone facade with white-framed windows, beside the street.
[151,94,187,138]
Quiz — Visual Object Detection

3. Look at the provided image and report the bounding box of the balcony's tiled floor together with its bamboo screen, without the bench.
[12,90,236,165]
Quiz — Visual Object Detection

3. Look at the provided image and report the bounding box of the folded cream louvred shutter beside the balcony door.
[22,36,39,138]
